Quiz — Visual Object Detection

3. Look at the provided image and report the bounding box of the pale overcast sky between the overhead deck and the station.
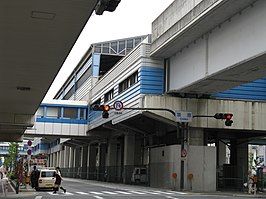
[45,0,174,100]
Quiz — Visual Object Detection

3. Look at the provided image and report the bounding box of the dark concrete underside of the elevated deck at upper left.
[0,0,98,141]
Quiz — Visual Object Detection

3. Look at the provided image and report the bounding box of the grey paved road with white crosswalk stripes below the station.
[0,179,264,199]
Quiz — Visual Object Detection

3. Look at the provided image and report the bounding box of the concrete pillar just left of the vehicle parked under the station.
[123,134,135,183]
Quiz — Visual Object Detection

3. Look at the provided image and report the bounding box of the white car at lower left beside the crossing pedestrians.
[36,168,55,191]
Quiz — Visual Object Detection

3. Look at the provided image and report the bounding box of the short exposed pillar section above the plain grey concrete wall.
[188,128,204,146]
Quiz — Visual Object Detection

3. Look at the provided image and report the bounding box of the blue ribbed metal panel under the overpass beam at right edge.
[211,78,266,100]
